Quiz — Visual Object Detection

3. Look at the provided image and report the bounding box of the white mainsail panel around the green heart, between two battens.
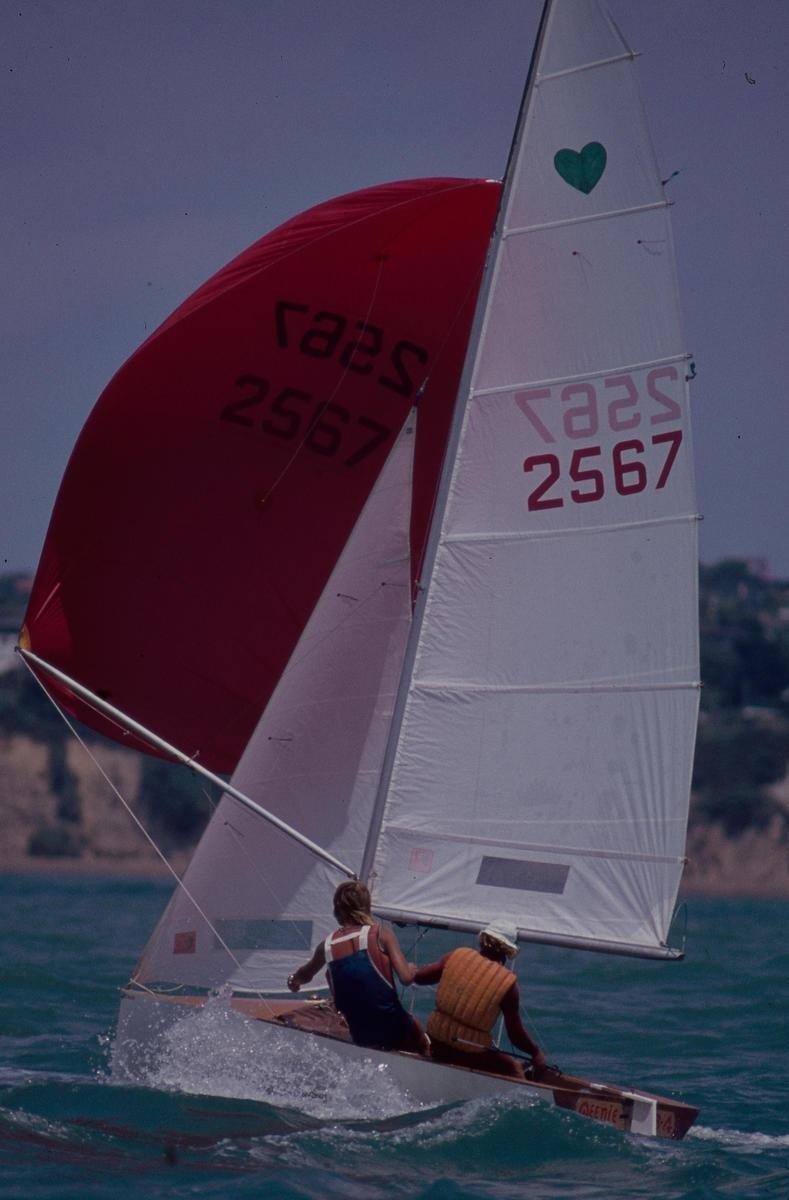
[506,59,664,230]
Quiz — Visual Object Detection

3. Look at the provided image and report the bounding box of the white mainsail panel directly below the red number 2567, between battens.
[417,522,698,686]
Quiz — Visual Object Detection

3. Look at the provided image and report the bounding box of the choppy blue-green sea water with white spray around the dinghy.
[0,876,789,1200]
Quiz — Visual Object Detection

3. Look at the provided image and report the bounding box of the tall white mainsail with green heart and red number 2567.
[368,0,698,954]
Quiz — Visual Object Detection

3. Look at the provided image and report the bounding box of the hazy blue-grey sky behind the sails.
[0,0,789,577]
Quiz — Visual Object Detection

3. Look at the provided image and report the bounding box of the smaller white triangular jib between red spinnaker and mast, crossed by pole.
[135,414,416,992]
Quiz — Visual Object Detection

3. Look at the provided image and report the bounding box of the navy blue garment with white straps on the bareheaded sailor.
[324,925,411,1050]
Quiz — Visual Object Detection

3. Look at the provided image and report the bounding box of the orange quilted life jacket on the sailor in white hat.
[427,946,516,1054]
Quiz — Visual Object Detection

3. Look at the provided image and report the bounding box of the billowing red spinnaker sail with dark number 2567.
[25,179,500,772]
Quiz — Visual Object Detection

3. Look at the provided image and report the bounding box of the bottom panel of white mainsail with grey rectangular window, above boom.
[373,829,682,946]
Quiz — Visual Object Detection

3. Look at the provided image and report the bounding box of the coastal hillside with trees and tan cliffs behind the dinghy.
[0,560,789,896]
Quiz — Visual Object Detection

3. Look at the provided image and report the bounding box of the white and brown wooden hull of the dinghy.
[116,989,699,1139]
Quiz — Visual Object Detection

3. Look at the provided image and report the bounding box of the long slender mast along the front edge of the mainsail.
[360,0,554,883]
